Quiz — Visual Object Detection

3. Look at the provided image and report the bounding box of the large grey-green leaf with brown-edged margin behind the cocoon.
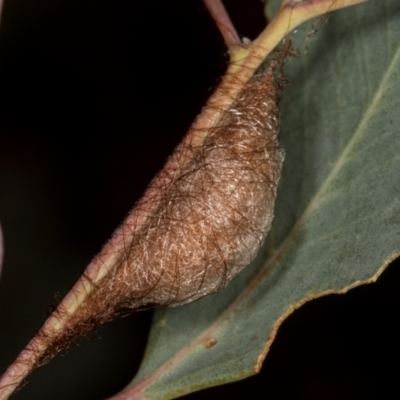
[112,0,400,399]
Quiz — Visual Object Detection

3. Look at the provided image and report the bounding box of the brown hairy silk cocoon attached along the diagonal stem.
[36,67,284,361]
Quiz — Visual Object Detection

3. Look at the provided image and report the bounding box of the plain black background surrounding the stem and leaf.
[0,0,400,400]
